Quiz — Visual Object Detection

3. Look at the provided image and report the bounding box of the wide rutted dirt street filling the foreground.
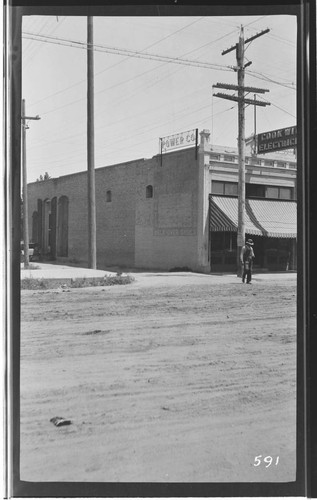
[21,273,296,482]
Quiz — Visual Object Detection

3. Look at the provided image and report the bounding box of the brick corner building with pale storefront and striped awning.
[28,130,297,273]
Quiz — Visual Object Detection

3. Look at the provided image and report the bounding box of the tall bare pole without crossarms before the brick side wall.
[87,16,97,269]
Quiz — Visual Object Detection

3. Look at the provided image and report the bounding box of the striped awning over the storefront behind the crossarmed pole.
[209,196,297,238]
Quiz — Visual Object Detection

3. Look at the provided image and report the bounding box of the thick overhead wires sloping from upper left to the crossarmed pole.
[22,33,232,71]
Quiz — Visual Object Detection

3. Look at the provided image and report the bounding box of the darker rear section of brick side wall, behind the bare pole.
[28,160,143,268]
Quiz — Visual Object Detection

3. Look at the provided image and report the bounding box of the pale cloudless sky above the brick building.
[22,15,296,182]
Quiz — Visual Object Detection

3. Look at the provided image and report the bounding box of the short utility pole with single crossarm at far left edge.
[21,99,40,269]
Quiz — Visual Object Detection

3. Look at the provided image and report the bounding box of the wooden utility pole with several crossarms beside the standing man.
[214,26,270,276]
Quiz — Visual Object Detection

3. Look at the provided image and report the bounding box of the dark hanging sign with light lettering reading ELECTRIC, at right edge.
[256,127,297,154]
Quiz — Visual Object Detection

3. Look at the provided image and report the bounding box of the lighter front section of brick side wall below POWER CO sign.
[135,149,198,270]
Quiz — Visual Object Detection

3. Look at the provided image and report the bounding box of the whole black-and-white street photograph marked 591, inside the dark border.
[9,0,303,492]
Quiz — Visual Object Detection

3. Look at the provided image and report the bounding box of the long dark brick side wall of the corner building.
[28,149,198,270]
